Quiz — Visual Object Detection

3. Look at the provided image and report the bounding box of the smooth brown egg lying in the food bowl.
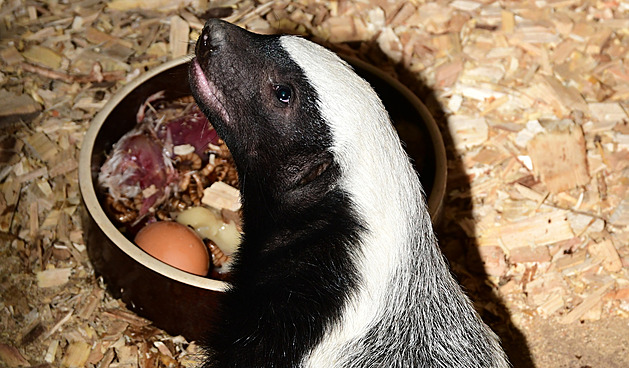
[135,221,210,276]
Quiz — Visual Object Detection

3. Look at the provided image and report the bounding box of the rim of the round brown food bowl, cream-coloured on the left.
[78,55,446,291]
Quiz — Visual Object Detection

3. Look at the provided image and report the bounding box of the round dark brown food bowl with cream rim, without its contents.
[79,58,446,340]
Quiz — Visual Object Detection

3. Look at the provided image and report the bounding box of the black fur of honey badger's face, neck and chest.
[190,20,363,368]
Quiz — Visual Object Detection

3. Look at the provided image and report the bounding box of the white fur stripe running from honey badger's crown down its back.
[281,36,421,367]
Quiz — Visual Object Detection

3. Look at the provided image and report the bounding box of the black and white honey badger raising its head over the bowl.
[190,20,509,368]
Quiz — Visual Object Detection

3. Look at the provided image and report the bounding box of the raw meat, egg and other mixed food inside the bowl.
[98,92,240,279]
